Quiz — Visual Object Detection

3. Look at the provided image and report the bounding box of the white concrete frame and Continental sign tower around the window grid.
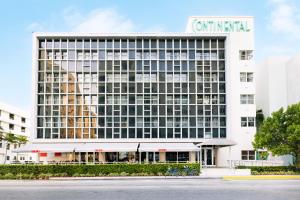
[27,17,262,166]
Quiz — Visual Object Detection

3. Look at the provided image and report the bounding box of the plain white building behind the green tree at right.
[256,55,300,165]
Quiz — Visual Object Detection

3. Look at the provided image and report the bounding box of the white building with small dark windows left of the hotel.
[0,103,36,164]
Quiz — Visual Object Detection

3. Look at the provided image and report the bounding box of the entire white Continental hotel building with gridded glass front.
[19,17,259,166]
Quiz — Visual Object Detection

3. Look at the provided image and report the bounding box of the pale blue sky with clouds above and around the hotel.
[0,0,300,111]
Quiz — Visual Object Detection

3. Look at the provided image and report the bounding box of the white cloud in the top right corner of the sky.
[269,0,300,38]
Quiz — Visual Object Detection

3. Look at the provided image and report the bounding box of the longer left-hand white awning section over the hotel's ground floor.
[14,143,138,153]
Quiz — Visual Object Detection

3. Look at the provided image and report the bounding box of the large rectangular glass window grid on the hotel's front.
[37,38,226,139]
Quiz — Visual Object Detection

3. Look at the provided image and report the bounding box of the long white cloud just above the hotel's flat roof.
[25,7,165,33]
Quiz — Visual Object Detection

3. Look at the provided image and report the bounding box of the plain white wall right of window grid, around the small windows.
[187,16,256,166]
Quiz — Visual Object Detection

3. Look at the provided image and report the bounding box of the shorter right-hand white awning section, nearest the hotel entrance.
[139,143,200,152]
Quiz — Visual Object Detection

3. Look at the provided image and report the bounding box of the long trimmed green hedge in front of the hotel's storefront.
[0,163,199,179]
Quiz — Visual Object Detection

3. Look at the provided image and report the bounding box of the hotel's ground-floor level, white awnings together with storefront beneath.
[14,143,238,167]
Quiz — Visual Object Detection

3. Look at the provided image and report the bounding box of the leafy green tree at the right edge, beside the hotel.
[253,103,300,166]
